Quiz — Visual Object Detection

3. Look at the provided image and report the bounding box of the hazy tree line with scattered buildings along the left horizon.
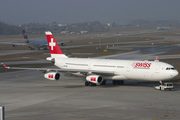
[0,21,114,35]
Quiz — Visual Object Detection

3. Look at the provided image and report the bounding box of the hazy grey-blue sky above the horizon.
[0,0,180,24]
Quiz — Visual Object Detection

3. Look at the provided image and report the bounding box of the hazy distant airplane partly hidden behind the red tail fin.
[13,30,72,50]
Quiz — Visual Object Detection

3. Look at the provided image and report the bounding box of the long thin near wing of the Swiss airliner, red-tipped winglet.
[1,63,115,76]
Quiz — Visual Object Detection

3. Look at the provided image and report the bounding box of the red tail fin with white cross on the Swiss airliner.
[45,31,67,58]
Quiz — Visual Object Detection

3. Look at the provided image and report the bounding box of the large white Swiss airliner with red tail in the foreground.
[2,31,179,86]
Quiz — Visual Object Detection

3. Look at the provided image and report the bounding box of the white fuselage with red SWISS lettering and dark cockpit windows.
[55,58,178,81]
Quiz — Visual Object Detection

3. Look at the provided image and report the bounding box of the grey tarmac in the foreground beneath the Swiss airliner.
[0,70,180,120]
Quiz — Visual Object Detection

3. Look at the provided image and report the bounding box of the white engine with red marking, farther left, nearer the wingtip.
[44,72,60,80]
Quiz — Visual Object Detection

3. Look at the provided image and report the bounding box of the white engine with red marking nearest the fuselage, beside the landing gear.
[86,75,103,84]
